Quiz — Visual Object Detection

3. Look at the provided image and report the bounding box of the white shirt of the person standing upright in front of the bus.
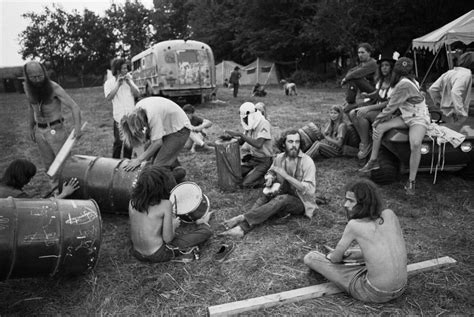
[104,76,138,123]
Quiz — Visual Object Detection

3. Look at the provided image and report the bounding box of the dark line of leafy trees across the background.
[19,0,474,82]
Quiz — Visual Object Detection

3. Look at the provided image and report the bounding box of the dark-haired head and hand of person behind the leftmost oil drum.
[0,159,79,199]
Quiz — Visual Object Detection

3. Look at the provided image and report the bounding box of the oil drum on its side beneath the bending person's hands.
[59,155,145,214]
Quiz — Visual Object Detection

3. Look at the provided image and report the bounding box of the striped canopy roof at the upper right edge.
[412,10,474,53]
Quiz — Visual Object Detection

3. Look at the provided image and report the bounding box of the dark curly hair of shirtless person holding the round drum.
[130,165,176,214]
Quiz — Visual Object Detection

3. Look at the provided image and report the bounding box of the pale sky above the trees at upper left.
[0,0,153,67]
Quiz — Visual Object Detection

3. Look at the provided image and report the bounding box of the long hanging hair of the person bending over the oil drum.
[120,108,150,147]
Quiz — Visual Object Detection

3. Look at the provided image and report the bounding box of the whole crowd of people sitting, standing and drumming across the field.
[0,43,472,303]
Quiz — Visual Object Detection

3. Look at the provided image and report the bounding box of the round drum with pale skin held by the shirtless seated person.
[170,182,210,222]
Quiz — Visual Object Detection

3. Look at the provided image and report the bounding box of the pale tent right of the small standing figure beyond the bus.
[240,58,279,85]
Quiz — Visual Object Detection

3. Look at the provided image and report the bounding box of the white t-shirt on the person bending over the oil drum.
[136,97,191,141]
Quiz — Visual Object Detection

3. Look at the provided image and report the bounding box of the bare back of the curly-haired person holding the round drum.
[129,200,171,255]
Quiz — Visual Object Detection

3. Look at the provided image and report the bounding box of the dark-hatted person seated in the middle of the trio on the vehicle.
[349,57,395,160]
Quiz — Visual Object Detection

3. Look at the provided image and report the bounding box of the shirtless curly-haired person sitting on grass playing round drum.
[129,165,212,262]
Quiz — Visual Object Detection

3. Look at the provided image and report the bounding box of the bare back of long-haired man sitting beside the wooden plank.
[348,209,407,291]
